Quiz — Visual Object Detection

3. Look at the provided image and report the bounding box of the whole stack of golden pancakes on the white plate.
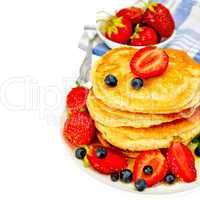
[87,47,200,156]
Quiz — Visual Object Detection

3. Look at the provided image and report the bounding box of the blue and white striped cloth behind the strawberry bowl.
[79,0,200,63]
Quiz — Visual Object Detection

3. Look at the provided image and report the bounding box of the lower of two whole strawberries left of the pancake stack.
[64,112,95,146]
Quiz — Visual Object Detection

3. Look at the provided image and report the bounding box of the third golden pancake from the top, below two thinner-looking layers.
[96,108,200,151]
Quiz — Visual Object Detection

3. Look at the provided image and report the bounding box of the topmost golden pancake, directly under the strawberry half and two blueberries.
[91,47,200,114]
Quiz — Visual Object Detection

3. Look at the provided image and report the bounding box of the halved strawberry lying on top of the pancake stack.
[130,47,169,78]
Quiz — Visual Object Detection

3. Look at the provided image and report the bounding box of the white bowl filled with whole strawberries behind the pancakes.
[96,2,175,49]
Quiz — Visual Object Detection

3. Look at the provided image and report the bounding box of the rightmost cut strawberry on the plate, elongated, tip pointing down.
[167,142,197,183]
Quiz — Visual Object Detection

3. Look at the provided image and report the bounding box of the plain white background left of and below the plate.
[0,0,200,200]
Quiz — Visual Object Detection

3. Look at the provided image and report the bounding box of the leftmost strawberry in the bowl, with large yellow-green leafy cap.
[99,16,132,44]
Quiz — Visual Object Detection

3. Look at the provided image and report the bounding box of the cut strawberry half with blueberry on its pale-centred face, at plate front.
[133,150,168,187]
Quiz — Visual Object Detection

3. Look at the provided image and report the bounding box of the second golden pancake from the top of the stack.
[87,90,199,128]
